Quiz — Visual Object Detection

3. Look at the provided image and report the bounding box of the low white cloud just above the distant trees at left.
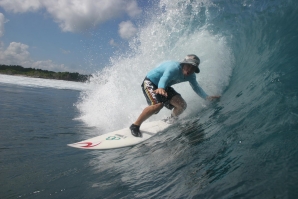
[0,42,73,72]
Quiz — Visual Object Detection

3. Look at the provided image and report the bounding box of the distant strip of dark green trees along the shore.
[0,65,90,82]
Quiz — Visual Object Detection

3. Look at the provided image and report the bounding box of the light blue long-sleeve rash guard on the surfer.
[147,61,208,99]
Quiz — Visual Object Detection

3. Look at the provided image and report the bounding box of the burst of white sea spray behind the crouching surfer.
[77,1,234,134]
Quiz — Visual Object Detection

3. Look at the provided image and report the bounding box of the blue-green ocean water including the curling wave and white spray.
[0,0,298,199]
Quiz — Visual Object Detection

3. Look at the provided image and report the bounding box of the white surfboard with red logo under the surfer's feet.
[68,121,170,149]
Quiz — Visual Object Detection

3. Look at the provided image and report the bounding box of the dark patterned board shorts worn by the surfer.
[142,78,180,110]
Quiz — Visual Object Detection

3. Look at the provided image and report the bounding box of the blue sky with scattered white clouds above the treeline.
[0,0,152,74]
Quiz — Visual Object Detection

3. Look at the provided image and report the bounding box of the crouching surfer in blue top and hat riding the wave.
[130,54,220,137]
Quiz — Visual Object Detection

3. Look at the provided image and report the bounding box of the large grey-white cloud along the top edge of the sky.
[0,0,141,32]
